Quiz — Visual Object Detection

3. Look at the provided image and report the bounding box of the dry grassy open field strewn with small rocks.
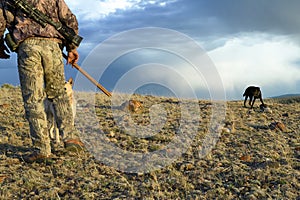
[0,85,300,199]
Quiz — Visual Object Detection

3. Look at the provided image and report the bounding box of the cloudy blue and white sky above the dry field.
[0,0,300,99]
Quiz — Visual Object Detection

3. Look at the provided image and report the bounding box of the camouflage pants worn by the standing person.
[17,38,79,155]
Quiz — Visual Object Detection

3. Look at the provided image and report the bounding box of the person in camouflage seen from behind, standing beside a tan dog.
[0,0,84,163]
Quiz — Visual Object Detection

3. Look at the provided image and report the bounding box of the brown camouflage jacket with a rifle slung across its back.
[0,0,78,51]
